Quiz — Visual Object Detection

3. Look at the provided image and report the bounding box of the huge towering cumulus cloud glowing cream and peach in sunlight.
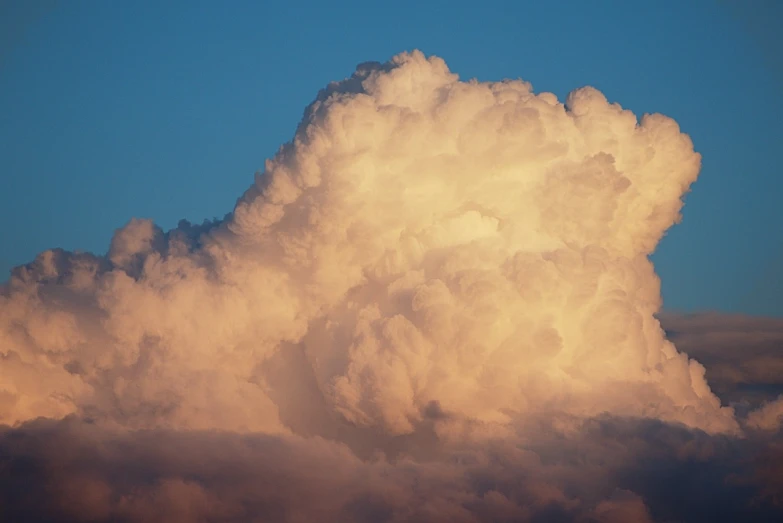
[2,48,736,434]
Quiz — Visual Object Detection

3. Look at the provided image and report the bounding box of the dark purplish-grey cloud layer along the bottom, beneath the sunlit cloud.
[0,416,783,522]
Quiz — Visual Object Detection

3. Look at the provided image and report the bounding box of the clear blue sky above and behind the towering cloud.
[0,0,783,315]
